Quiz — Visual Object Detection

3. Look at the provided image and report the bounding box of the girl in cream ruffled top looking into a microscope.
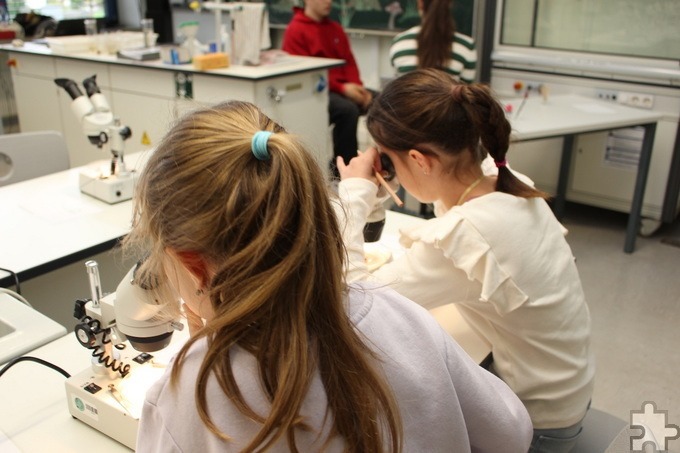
[338,69,595,452]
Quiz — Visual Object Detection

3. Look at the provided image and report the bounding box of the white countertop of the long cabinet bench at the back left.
[0,42,345,80]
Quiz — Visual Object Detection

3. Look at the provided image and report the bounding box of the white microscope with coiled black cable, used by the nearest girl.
[66,261,188,450]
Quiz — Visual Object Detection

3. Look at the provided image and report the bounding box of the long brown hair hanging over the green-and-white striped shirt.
[416,0,456,69]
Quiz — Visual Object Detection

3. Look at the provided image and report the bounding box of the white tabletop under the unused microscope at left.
[0,151,150,276]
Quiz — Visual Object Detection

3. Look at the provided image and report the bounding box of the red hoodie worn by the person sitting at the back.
[281,7,363,94]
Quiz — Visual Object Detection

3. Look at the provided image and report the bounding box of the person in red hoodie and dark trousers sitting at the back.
[281,0,375,177]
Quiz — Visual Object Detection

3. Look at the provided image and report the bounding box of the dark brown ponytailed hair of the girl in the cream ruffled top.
[366,69,548,198]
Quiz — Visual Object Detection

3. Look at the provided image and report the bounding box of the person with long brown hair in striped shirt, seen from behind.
[390,0,477,83]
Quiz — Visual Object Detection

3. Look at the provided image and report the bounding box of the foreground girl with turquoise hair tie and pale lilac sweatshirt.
[125,101,531,453]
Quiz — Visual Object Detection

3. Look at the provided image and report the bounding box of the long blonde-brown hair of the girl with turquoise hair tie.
[126,101,402,452]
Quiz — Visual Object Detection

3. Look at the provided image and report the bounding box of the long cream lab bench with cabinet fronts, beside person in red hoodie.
[0,42,344,168]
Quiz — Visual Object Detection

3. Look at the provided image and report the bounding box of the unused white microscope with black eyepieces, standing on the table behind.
[54,75,138,204]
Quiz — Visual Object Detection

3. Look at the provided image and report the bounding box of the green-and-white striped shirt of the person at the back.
[390,25,477,83]
